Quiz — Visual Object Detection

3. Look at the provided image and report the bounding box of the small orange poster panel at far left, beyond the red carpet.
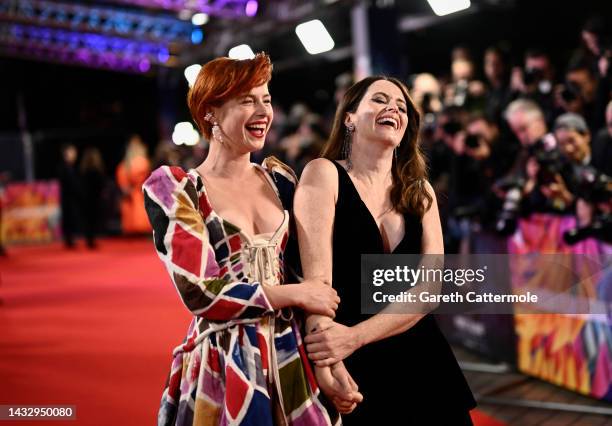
[2,180,61,244]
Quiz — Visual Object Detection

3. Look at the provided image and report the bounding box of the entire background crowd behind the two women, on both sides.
[1,18,612,253]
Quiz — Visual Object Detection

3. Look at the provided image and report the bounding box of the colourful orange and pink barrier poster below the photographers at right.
[509,214,612,401]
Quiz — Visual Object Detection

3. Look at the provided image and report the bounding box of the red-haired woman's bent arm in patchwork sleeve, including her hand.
[143,166,337,321]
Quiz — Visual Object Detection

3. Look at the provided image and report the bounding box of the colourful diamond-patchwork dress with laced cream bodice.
[143,159,340,426]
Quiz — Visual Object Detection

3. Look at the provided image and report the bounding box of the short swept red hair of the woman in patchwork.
[187,52,272,139]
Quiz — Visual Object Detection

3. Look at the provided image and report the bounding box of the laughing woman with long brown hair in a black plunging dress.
[294,76,475,425]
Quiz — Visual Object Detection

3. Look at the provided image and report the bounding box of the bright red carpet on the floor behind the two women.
[0,239,503,426]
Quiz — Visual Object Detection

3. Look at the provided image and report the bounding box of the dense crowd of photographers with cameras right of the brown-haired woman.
[402,19,612,253]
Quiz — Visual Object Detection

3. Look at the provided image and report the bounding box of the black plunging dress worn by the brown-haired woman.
[332,162,476,426]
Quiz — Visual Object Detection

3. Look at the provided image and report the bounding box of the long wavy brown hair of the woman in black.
[321,76,433,217]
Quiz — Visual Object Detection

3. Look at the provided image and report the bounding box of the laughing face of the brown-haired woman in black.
[345,80,408,147]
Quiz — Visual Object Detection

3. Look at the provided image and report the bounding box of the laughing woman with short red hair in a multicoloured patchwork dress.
[143,54,360,425]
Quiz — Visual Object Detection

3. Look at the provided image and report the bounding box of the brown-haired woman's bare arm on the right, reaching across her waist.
[304,182,444,366]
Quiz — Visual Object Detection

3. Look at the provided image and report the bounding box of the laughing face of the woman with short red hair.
[213,84,274,154]
